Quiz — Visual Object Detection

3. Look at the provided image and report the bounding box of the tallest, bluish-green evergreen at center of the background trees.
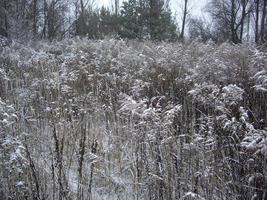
[119,0,177,41]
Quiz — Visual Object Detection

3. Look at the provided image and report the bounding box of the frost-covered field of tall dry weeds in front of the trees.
[0,39,267,200]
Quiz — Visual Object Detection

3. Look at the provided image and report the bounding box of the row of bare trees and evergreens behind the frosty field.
[0,0,267,44]
